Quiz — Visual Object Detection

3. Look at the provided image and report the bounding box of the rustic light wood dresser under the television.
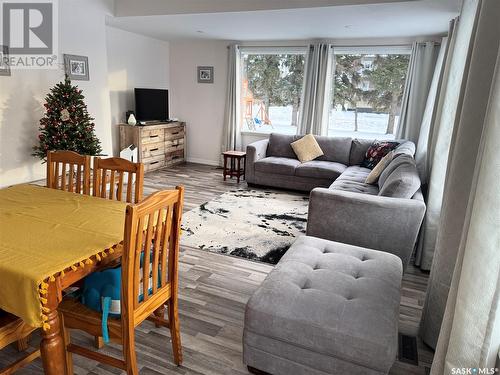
[118,121,186,172]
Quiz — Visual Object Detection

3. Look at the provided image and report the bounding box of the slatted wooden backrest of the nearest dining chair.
[122,187,184,324]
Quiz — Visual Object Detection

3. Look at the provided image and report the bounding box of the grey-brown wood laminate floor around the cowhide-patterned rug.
[0,164,432,375]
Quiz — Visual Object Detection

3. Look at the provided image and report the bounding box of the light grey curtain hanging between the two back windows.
[297,43,334,135]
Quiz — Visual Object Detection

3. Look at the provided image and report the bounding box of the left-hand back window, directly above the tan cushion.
[240,47,306,134]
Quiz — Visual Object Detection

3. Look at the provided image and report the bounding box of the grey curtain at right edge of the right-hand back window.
[396,42,440,144]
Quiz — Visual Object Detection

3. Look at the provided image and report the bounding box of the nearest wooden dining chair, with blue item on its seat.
[59,187,184,375]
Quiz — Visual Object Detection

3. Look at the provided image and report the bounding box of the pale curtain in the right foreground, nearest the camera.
[431,29,500,375]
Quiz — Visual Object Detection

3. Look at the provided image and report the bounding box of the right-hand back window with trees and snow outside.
[328,49,410,139]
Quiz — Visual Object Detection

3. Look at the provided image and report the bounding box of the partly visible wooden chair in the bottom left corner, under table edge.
[0,310,40,375]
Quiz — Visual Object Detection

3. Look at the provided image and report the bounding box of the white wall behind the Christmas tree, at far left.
[0,0,113,186]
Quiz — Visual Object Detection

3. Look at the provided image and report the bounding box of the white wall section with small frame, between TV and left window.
[170,41,228,165]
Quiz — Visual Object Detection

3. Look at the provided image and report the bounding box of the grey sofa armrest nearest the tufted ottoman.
[307,188,425,268]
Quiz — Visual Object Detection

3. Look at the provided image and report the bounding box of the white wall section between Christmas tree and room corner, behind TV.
[106,26,170,155]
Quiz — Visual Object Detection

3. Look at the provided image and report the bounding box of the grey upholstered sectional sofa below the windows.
[246,133,425,268]
